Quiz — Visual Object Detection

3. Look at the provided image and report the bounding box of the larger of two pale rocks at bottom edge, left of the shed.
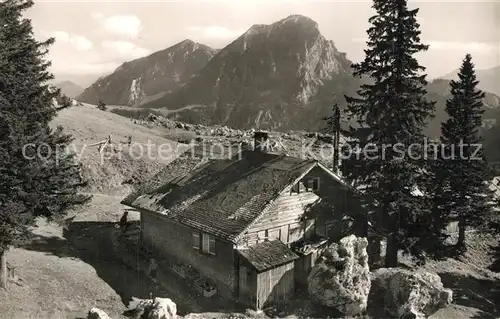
[134,298,177,319]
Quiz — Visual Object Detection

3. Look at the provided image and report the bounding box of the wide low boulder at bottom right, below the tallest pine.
[370,268,453,319]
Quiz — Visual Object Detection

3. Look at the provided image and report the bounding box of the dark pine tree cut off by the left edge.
[0,0,89,287]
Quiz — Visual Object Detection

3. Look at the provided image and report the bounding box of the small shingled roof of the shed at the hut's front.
[238,239,299,272]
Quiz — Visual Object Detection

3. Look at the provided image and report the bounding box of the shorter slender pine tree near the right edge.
[434,54,492,252]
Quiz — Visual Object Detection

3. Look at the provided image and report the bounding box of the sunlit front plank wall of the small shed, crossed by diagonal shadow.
[257,261,295,309]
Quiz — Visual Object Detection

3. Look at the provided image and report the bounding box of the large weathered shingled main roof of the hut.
[123,151,317,242]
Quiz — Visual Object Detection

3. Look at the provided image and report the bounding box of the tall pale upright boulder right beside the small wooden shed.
[307,235,371,316]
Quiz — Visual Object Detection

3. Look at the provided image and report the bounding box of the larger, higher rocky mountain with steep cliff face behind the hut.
[143,15,359,130]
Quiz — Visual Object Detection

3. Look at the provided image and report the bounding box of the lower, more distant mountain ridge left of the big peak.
[77,40,217,106]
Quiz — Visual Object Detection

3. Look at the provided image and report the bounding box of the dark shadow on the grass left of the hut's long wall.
[22,222,230,315]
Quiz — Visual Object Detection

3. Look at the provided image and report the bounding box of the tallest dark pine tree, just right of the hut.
[346,0,434,267]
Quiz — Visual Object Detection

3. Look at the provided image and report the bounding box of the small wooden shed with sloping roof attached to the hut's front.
[238,240,299,309]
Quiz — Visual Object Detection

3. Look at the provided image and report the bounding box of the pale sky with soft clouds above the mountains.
[26,0,500,86]
